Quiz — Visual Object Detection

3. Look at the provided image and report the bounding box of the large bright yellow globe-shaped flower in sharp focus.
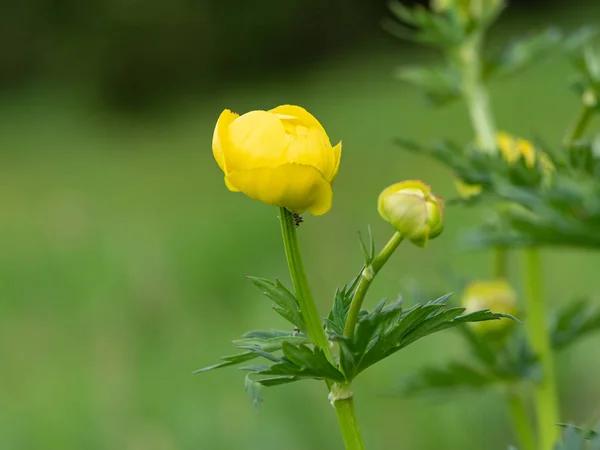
[212,105,342,215]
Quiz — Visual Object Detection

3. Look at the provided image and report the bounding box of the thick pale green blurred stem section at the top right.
[458,33,496,153]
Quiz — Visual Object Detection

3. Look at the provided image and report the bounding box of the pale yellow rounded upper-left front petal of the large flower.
[223,111,289,171]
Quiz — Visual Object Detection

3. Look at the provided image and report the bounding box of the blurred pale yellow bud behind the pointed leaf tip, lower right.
[462,279,517,333]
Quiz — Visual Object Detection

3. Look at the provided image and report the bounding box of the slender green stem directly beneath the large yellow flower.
[279,208,333,362]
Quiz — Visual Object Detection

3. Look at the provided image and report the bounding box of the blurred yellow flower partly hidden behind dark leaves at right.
[454,131,555,199]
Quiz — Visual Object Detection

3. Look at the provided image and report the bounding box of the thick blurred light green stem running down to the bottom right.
[525,247,559,450]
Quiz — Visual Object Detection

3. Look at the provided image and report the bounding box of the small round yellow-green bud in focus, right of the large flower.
[377,180,444,247]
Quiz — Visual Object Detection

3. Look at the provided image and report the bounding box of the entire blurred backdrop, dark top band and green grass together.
[0,0,600,450]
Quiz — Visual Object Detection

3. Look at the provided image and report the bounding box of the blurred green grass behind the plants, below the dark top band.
[0,9,600,450]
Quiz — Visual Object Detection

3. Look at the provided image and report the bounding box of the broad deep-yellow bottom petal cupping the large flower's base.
[227,164,333,216]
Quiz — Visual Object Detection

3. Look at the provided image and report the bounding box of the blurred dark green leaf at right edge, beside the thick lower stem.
[550,299,600,350]
